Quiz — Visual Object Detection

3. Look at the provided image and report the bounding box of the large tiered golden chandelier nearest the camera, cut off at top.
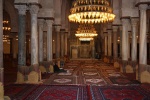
[68,0,115,23]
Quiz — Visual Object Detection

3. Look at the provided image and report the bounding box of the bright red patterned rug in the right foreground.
[91,86,150,100]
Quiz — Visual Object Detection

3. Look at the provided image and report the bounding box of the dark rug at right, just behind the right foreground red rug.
[108,77,139,85]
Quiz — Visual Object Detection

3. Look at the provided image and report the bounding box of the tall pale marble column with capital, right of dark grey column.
[30,5,39,65]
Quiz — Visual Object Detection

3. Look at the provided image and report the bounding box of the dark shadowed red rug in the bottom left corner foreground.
[4,84,38,100]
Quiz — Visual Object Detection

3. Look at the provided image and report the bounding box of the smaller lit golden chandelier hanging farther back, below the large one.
[75,24,97,41]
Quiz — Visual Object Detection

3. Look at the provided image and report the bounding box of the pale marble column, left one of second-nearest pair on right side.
[122,19,129,61]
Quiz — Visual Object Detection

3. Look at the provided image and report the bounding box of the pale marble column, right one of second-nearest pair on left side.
[46,20,53,62]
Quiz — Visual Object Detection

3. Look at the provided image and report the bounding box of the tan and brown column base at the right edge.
[136,64,150,83]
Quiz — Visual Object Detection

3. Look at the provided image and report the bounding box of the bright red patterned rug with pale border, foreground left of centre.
[23,85,88,100]
